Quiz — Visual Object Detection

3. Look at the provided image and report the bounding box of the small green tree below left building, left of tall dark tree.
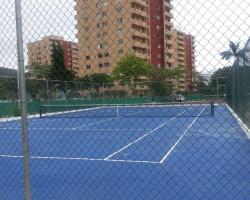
[26,63,52,79]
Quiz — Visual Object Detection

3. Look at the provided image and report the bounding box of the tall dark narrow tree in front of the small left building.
[49,42,75,81]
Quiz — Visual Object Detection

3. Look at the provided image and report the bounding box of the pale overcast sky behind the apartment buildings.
[0,0,250,75]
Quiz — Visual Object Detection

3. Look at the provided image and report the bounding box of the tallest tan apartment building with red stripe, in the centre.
[75,0,173,76]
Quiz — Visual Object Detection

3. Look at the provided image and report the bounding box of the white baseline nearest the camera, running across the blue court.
[0,155,160,164]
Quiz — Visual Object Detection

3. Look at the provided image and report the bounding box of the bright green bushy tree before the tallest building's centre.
[112,53,153,88]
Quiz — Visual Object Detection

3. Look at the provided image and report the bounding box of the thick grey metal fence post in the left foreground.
[15,0,31,200]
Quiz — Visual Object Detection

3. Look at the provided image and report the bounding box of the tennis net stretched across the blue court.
[40,101,214,118]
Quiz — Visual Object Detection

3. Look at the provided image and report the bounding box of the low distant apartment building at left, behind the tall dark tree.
[27,35,79,71]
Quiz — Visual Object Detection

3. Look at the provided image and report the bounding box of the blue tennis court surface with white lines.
[0,105,250,200]
